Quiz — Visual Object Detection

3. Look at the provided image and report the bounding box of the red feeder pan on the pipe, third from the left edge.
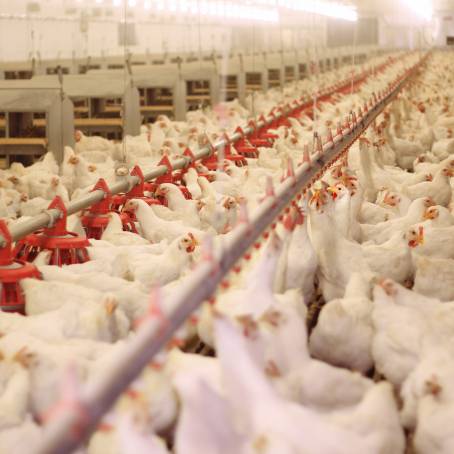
[81,178,136,240]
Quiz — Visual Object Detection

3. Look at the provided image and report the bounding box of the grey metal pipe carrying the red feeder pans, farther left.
[0,54,398,247]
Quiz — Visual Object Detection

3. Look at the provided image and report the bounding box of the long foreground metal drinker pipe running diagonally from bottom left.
[36,54,423,454]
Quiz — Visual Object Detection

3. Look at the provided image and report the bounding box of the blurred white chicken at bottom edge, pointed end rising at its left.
[216,319,379,454]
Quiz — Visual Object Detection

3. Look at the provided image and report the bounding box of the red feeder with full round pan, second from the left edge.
[15,196,90,266]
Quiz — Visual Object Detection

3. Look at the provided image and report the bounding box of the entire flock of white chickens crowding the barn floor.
[0,49,454,454]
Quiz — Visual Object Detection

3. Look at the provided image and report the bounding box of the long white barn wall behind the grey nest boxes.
[0,0,326,61]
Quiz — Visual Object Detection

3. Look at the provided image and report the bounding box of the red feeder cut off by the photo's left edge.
[0,219,41,314]
